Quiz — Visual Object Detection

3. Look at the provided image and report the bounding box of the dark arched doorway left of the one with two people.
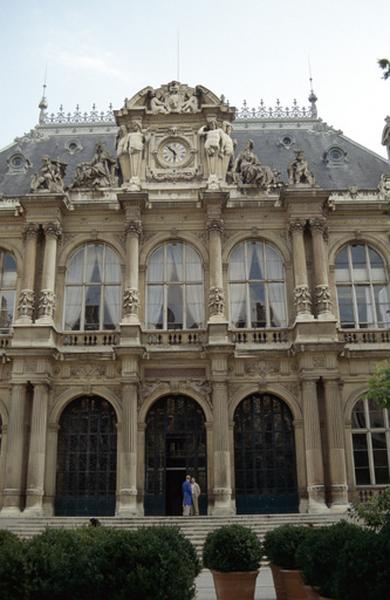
[55,396,117,516]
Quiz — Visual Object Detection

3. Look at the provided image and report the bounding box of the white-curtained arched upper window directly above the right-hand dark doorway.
[229,240,287,327]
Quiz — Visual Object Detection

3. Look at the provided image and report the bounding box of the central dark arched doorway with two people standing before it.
[145,395,207,515]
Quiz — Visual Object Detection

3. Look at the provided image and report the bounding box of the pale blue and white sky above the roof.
[0,0,390,156]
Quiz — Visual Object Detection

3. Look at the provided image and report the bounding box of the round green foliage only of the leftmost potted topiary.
[203,525,262,572]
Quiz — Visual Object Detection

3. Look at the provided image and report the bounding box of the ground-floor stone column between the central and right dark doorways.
[213,381,233,515]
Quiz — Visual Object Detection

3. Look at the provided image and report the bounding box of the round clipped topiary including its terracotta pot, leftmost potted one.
[203,525,262,600]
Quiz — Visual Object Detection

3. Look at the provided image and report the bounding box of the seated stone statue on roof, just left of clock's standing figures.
[72,144,116,188]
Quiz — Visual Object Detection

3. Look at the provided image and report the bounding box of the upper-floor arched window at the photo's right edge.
[335,243,390,328]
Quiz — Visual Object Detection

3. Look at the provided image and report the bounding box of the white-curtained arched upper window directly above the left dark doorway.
[64,243,121,331]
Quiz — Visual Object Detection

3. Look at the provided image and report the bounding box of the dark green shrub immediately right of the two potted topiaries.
[296,521,361,598]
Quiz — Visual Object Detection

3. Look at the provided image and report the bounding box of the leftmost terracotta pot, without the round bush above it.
[211,571,259,600]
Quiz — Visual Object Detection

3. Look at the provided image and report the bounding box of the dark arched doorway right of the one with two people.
[234,393,298,513]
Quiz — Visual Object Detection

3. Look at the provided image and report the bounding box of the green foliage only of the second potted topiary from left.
[264,525,312,569]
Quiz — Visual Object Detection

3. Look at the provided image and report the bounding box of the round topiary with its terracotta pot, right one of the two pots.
[263,525,311,600]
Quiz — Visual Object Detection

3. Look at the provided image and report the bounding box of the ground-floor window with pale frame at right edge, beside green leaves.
[352,398,390,485]
